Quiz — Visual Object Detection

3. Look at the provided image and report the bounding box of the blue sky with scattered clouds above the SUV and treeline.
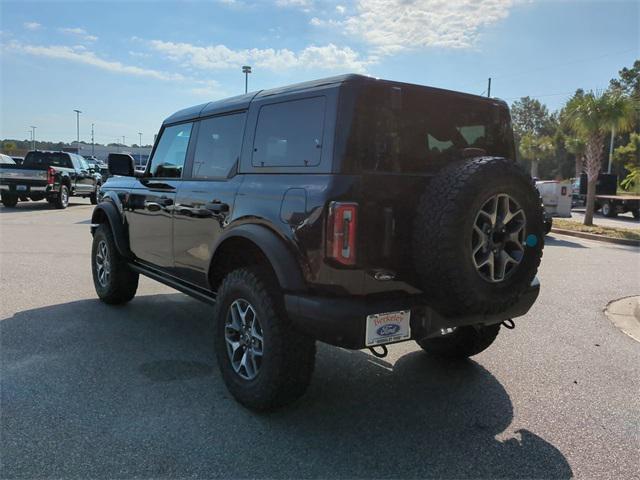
[0,0,640,144]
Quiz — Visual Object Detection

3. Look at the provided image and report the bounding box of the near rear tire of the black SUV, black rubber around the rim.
[213,268,316,411]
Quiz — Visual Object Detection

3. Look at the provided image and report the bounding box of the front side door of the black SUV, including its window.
[125,122,193,270]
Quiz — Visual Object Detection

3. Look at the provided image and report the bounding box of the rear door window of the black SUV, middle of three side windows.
[192,113,245,178]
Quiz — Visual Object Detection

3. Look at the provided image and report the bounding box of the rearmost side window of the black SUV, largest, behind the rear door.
[252,97,325,167]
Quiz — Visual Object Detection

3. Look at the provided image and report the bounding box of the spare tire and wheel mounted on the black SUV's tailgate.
[412,157,544,316]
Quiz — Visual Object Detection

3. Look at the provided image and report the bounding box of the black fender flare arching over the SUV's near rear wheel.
[209,224,307,292]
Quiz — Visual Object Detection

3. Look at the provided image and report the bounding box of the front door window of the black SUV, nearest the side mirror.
[149,123,193,178]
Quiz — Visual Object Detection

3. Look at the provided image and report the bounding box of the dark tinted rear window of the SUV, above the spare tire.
[338,85,514,173]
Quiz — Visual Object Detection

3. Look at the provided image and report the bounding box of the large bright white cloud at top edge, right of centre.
[311,0,516,54]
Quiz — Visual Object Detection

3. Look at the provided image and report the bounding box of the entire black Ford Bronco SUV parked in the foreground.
[91,75,544,410]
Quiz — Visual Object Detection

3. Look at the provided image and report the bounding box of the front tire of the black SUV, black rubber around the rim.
[91,223,140,305]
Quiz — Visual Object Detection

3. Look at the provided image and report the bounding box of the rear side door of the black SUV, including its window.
[173,112,246,288]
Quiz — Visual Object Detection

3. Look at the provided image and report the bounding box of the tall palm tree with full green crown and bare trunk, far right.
[567,90,637,225]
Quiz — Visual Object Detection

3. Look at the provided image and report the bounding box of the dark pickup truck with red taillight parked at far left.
[0,150,102,208]
